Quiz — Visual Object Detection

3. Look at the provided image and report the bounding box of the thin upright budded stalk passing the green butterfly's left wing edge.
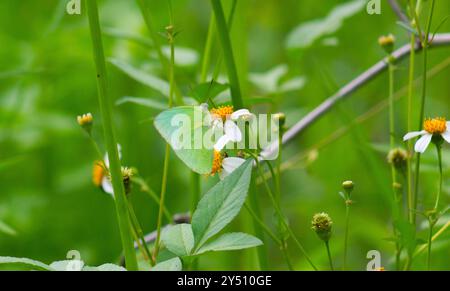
[153,10,175,260]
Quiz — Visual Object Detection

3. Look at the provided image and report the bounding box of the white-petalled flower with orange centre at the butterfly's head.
[200,103,251,151]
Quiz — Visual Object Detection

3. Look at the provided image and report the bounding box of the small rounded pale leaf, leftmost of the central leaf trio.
[162,223,194,257]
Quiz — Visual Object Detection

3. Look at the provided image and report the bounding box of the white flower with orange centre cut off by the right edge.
[403,117,450,153]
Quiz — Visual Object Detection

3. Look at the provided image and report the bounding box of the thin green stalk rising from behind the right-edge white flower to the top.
[413,0,435,223]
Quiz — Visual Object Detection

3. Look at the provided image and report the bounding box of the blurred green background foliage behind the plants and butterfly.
[0,0,450,270]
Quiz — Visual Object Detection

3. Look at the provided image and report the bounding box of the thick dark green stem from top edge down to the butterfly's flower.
[211,0,244,109]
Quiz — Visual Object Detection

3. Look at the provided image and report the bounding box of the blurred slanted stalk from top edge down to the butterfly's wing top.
[136,0,184,105]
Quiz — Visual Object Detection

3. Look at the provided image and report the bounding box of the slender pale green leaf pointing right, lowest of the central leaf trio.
[195,232,263,255]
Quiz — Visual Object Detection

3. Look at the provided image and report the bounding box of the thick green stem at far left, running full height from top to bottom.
[86,0,138,270]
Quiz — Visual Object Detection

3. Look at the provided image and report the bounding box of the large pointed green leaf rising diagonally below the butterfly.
[192,159,253,250]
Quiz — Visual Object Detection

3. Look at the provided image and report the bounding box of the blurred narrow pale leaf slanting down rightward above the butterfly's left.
[109,59,170,97]
